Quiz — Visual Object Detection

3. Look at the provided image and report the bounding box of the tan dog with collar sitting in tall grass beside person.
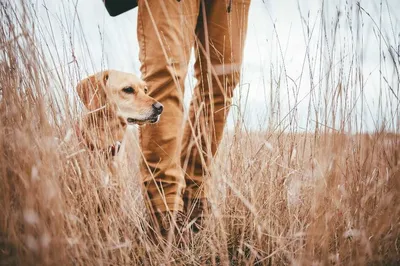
[76,70,163,155]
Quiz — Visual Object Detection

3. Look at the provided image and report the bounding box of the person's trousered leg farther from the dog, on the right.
[181,0,250,229]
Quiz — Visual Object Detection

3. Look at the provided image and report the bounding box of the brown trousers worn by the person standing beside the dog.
[137,0,250,212]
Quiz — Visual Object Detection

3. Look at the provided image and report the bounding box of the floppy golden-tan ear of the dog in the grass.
[76,71,109,111]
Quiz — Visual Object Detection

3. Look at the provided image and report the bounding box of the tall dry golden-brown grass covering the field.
[0,0,400,265]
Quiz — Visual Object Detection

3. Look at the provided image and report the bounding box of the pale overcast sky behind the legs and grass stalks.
[33,0,400,130]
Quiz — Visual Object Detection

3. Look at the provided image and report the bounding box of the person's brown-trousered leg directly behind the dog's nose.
[138,0,199,229]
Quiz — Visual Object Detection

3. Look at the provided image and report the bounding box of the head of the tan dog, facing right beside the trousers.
[77,70,163,125]
